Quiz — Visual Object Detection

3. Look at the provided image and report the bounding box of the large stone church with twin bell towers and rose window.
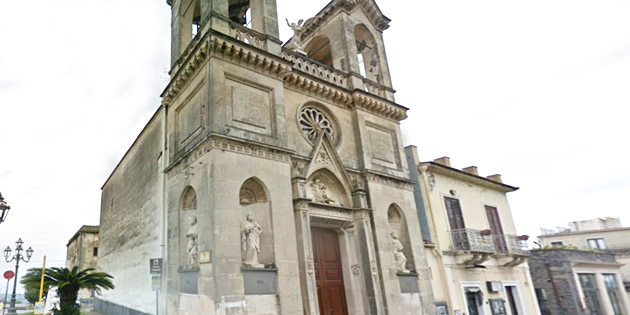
[95,0,435,315]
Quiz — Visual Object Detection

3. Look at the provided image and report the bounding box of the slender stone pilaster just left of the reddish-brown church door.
[294,199,319,315]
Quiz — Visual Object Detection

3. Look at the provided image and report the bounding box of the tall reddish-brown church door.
[311,228,348,315]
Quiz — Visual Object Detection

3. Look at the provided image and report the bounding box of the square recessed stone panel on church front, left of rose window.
[226,78,273,135]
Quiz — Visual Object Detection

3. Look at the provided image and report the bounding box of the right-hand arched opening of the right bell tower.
[354,24,381,83]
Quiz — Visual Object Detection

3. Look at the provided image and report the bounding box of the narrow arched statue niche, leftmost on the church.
[178,186,199,267]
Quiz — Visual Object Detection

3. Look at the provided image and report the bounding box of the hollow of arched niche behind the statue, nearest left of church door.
[238,177,275,265]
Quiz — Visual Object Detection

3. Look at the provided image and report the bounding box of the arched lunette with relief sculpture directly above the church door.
[306,168,352,207]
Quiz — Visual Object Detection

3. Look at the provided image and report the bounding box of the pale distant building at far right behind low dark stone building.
[538,218,630,306]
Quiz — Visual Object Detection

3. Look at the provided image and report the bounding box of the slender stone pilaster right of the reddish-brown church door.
[356,210,385,314]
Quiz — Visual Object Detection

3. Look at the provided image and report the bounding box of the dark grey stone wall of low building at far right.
[529,249,616,315]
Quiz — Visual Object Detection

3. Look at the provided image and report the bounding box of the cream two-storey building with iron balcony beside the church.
[406,146,540,315]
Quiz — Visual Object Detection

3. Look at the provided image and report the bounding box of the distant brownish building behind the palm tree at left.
[66,225,99,303]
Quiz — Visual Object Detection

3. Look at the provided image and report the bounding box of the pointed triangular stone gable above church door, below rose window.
[304,133,352,207]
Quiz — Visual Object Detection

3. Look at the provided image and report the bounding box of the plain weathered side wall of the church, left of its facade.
[98,110,163,314]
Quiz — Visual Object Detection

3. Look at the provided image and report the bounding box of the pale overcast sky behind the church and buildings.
[0,0,630,289]
